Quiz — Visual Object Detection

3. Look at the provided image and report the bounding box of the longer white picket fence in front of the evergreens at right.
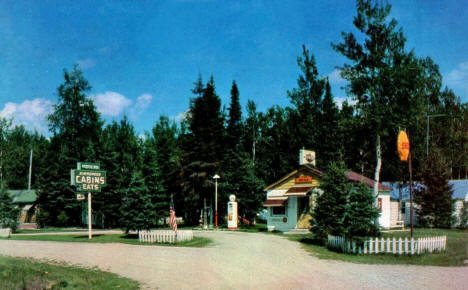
[328,236,447,255]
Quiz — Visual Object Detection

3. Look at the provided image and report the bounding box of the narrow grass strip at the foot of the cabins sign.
[6,233,212,247]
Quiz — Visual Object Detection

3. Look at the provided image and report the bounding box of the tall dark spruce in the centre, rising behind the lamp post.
[180,77,225,224]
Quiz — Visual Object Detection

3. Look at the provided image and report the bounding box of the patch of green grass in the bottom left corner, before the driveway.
[0,256,139,290]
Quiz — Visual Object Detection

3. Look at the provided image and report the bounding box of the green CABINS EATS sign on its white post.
[70,162,107,239]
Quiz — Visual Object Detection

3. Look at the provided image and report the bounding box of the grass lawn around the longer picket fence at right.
[287,229,468,266]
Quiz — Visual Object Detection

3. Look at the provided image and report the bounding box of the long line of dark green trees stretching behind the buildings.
[0,0,468,230]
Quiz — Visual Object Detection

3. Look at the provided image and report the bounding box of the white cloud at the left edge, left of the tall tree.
[0,98,53,134]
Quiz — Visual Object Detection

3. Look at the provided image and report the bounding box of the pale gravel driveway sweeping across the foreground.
[0,232,468,289]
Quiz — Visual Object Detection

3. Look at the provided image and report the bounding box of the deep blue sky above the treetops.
[0,0,468,134]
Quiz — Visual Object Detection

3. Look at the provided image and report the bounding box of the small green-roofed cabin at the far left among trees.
[8,189,37,228]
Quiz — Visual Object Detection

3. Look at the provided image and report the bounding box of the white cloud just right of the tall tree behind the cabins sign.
[90,91,132,117]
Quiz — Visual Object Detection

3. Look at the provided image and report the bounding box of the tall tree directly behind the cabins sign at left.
[38,66,102,226]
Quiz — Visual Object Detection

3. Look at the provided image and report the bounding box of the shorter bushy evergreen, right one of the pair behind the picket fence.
[343,182,379,242]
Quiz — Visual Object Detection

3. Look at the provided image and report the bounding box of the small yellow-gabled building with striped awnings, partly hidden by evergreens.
[264,164,398,232]
